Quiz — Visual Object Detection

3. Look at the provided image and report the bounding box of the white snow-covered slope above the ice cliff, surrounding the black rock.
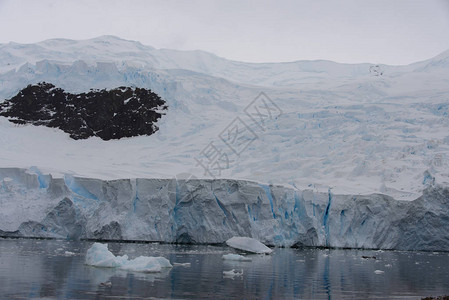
[0,36,449,200]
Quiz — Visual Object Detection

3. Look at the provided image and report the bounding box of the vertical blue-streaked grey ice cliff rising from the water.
[0,168,449,251]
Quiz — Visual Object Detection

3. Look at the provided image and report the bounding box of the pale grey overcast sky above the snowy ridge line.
[0,0,449,64]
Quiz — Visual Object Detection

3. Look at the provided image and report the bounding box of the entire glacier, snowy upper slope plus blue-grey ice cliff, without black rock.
[0,36,449,251]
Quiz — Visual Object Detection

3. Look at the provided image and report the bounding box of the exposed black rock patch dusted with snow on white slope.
[0,82,168,140]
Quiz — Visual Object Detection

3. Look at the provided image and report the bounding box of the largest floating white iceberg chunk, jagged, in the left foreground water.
[85,243,173,273]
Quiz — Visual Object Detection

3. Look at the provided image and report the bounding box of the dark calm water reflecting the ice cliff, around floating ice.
[0,239,449,299]
